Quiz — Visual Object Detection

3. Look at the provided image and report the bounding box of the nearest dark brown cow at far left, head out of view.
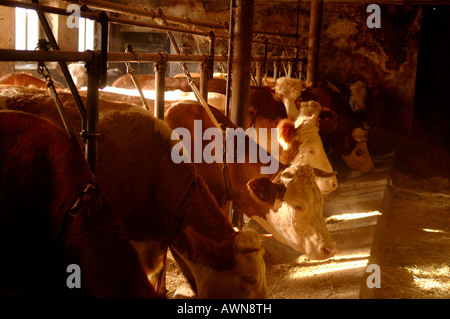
[0,111,157,299]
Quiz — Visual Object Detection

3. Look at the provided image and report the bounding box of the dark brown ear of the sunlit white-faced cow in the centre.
[247,177,286,205]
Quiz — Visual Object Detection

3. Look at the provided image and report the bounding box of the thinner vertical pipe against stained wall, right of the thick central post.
[306,0,323,87]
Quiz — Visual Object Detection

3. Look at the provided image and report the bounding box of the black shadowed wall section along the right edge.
[400,7,450,177]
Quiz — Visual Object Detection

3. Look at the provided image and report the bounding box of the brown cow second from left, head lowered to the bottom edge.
[0,87,268,298]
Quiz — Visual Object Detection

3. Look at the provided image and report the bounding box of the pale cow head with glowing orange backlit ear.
[278,101,338,194]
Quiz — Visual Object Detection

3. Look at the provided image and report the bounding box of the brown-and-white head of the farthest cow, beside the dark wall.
[342,127,374,173]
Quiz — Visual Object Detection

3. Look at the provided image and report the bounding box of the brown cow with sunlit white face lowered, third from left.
[164,101,337,259]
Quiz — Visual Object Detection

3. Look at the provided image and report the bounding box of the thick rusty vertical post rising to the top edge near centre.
[231,0,254,129]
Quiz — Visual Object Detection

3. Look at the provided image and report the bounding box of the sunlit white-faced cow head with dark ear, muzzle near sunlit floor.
[247,164,337,259]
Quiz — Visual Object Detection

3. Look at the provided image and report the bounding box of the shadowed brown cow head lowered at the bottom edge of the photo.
[172,227,269,299]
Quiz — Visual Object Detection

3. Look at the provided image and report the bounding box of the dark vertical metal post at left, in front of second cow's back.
[85,51,101,175]
